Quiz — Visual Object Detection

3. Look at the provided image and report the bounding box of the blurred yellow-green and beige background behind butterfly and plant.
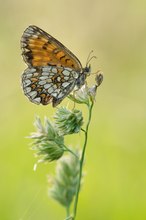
[0,0,146,220]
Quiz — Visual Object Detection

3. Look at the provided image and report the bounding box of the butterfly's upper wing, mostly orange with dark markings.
[21,25,82,72]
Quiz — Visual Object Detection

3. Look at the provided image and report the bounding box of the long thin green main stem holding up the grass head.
[73,102,94,220]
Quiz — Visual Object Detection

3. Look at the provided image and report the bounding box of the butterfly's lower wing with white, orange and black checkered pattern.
[22,66,78,107]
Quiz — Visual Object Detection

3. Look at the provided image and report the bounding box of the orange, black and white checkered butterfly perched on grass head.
[21,25,90,107]
